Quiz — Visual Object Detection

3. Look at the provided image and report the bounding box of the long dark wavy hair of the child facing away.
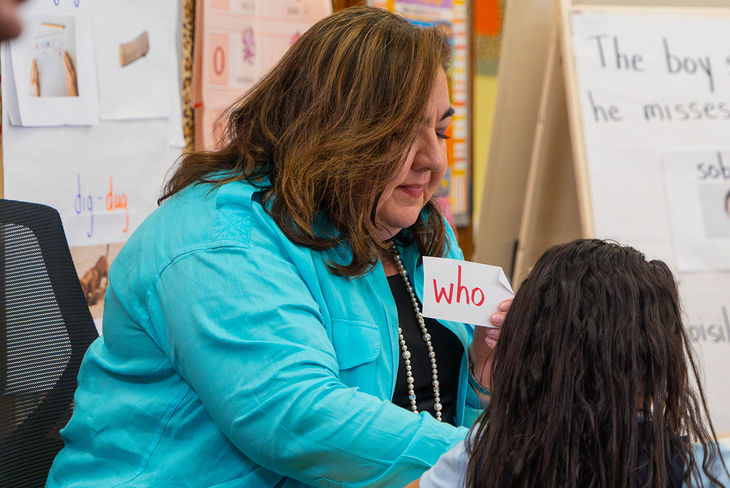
[466,239,727,488]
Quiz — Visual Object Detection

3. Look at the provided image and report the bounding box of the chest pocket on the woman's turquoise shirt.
[332,319,389,396]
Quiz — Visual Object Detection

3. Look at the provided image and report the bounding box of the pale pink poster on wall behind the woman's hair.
[193,0,332,149]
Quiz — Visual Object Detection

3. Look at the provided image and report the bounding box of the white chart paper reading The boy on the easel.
[570,9,730,431]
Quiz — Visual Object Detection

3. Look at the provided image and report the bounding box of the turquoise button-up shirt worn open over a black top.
[47,182,478,488]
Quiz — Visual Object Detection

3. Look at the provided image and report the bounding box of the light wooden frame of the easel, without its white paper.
[474,0,730,287]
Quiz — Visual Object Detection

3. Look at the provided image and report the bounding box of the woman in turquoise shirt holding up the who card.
[48,7,500,487]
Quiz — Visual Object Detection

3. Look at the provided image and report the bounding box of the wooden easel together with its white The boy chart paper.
[506,0,730,431]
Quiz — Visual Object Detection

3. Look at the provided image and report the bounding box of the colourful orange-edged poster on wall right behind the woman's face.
[367,0,471,225]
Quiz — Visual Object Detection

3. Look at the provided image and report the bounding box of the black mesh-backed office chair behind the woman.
[0,200,97,488]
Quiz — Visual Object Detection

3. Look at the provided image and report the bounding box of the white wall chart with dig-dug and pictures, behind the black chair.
[0,0,183,332]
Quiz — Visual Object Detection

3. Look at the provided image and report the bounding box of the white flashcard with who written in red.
[422,256,514,327]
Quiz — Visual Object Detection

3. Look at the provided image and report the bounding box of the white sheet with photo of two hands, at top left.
[8,1,98,127]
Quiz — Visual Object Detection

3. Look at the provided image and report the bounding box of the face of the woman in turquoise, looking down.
[375,69,454,240]
